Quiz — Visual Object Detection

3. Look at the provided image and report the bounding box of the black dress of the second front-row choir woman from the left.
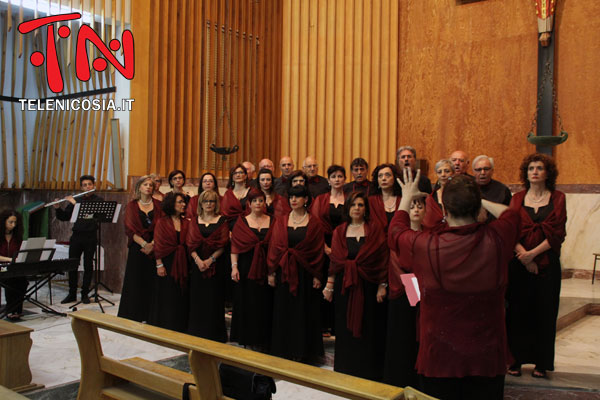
[148,232,189,332]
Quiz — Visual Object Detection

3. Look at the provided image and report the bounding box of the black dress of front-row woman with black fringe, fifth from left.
[271,227,324,361]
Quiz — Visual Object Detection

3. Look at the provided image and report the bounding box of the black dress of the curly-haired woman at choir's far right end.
[506,202,561,371]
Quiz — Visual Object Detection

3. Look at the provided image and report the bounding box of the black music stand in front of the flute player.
[69,201,121,312]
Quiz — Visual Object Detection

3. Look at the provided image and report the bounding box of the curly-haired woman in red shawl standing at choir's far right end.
[506,153,567,378]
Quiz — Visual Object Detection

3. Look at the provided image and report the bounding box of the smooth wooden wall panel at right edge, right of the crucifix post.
[554,1,600,184]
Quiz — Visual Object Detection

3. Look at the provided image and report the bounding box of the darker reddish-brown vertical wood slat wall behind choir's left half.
[143,0,282,177]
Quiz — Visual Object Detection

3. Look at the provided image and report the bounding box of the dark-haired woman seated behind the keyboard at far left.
[0,210,27,321]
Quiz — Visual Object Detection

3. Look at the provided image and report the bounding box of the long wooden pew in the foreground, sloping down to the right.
[70,310,425,400]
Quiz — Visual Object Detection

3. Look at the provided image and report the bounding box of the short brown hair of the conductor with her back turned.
[442,175,481,219]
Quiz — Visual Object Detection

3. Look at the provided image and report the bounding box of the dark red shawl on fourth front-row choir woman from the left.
[231,218,273,284]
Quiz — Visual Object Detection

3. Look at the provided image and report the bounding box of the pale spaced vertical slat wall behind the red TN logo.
[0,0,130,190]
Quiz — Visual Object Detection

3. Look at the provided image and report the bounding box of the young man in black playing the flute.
[54,175,102,304]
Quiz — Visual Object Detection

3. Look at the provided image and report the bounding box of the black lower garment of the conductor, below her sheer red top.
[420,375,504,400]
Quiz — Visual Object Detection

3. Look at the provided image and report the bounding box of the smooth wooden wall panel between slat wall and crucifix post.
[397,0,536,183]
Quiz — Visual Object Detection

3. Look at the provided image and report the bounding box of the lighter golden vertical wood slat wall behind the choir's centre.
[281,0,399,174]
